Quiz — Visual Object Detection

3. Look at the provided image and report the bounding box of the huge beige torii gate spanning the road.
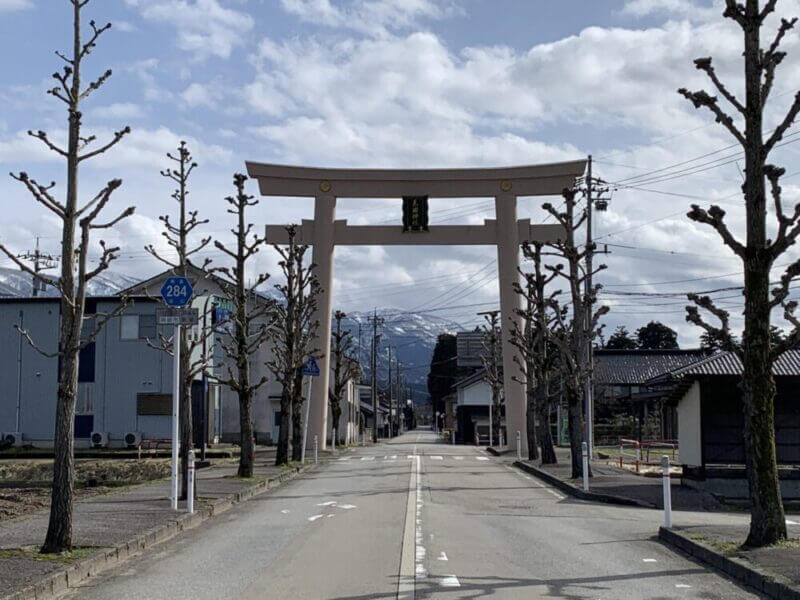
[247,160,586,453]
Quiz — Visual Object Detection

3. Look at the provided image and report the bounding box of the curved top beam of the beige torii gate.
[246,159,586,198]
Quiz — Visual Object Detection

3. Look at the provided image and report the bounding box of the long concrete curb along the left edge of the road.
[0,464,316,600]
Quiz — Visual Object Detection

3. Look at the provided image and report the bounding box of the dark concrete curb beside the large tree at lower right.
[658,527,800,600]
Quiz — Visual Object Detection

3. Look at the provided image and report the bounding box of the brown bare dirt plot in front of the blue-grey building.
[0,459,169,521]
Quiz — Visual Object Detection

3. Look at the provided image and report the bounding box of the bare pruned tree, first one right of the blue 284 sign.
[213,173,270,477]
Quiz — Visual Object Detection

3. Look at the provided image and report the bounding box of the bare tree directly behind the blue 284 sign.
[145,141,211,500]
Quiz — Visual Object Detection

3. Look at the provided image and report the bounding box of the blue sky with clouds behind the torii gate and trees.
[0,0,800,346]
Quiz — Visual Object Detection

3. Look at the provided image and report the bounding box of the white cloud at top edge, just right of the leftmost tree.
[125,0,254,60]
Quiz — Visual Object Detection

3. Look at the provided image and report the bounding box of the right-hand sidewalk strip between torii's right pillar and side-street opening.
[504,448,720,510]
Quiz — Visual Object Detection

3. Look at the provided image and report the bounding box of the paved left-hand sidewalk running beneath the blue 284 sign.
[0,450,313,598]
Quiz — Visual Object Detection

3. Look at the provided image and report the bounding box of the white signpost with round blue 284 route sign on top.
[158,277,193,510]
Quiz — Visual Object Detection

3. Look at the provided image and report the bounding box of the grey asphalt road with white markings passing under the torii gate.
[67,432,759,600]
